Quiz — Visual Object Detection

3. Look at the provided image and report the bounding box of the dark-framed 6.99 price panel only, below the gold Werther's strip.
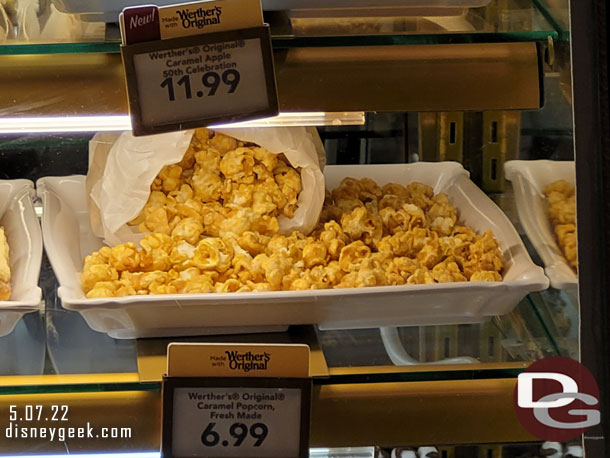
[162,378,311,458]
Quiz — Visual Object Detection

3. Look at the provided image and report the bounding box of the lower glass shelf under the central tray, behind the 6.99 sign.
[0,280,559,394]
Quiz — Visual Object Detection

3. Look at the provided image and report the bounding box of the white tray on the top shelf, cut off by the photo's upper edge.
[53,0,491,22]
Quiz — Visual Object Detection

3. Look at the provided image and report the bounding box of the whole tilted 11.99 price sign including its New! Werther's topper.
[121,0,278,135]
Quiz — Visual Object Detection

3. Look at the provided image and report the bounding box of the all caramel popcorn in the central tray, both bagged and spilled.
[82,175,504,297]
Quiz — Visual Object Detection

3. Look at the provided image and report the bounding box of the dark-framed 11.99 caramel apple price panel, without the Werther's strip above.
[121,26,279,135]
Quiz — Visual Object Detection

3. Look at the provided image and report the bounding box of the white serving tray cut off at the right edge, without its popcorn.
[504,160,578,290]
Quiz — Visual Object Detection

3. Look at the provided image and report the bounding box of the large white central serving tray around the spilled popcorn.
[37,162,548,338]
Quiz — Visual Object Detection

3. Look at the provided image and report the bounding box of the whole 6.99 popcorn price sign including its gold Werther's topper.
[161,344,311,458]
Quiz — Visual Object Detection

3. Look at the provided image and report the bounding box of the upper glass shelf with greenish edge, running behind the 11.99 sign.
[0,0,566,55]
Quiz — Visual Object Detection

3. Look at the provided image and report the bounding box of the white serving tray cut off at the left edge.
[0,180,42,336]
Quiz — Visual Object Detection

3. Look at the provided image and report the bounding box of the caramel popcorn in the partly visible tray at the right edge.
[543,180,578,272]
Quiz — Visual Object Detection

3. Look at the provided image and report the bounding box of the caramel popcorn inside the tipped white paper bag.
[129,129,302,244]
